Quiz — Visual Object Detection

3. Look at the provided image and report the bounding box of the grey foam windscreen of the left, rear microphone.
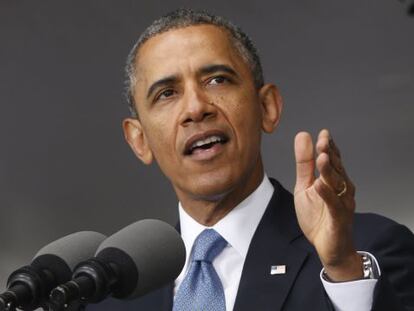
[31,231,106,283]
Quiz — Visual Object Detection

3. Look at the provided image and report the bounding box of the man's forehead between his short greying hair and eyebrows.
[136,25,247,87]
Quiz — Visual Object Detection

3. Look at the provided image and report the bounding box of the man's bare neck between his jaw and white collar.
[179,161,264,227]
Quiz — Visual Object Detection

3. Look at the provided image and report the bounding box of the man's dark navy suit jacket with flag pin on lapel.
[87,180,414,311]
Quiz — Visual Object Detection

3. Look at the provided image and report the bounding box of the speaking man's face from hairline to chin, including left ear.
[124,25,282,199]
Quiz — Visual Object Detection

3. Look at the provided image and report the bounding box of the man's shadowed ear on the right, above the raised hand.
[259,84,283,133]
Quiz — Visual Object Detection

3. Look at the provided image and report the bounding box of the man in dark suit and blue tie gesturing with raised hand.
[91,10,414,310]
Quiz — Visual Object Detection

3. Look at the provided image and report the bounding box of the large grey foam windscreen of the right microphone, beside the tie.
[96,219,185,299]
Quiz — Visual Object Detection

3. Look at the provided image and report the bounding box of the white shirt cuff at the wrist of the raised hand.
[320,252,381,311]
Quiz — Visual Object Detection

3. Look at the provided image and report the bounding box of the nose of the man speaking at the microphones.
[181,87,217,126]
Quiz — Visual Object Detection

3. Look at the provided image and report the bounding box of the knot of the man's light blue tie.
[193,229,227,262]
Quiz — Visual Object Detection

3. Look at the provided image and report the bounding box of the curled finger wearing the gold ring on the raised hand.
[316,152,345,193]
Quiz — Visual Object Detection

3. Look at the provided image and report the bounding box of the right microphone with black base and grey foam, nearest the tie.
[50,219,185,311]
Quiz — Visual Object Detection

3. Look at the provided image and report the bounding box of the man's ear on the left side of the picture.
[122,118,154,165]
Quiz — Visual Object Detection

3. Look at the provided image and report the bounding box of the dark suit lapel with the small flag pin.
[234,180,308,311]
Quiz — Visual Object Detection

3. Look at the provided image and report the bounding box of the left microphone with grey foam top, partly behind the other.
[0,231,106,311]
